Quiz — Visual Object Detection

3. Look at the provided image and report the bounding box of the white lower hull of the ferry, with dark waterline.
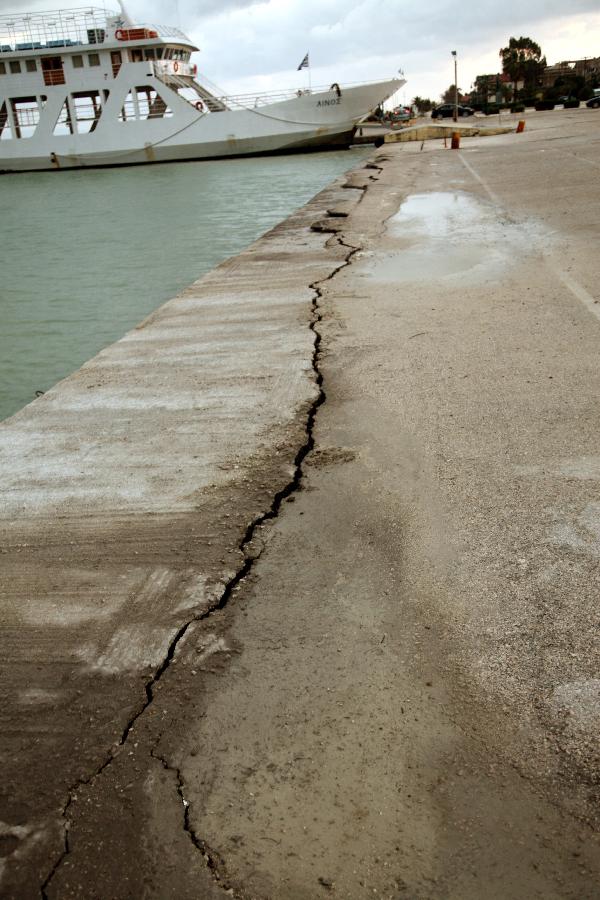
[0,80,400,172]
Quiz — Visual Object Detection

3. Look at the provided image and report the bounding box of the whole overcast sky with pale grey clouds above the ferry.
[0,0,600,101]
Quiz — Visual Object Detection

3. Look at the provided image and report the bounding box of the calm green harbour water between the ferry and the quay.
[0,149,369,419]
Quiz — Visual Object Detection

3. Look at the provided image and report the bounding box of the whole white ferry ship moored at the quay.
[0,3,405,172]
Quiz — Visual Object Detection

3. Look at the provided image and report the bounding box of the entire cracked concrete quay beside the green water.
[0,110,600,900]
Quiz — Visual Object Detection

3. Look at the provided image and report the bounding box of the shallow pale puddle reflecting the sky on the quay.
[364,191,535,282]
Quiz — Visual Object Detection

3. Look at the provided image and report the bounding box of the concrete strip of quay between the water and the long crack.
[0,171,366,896]
